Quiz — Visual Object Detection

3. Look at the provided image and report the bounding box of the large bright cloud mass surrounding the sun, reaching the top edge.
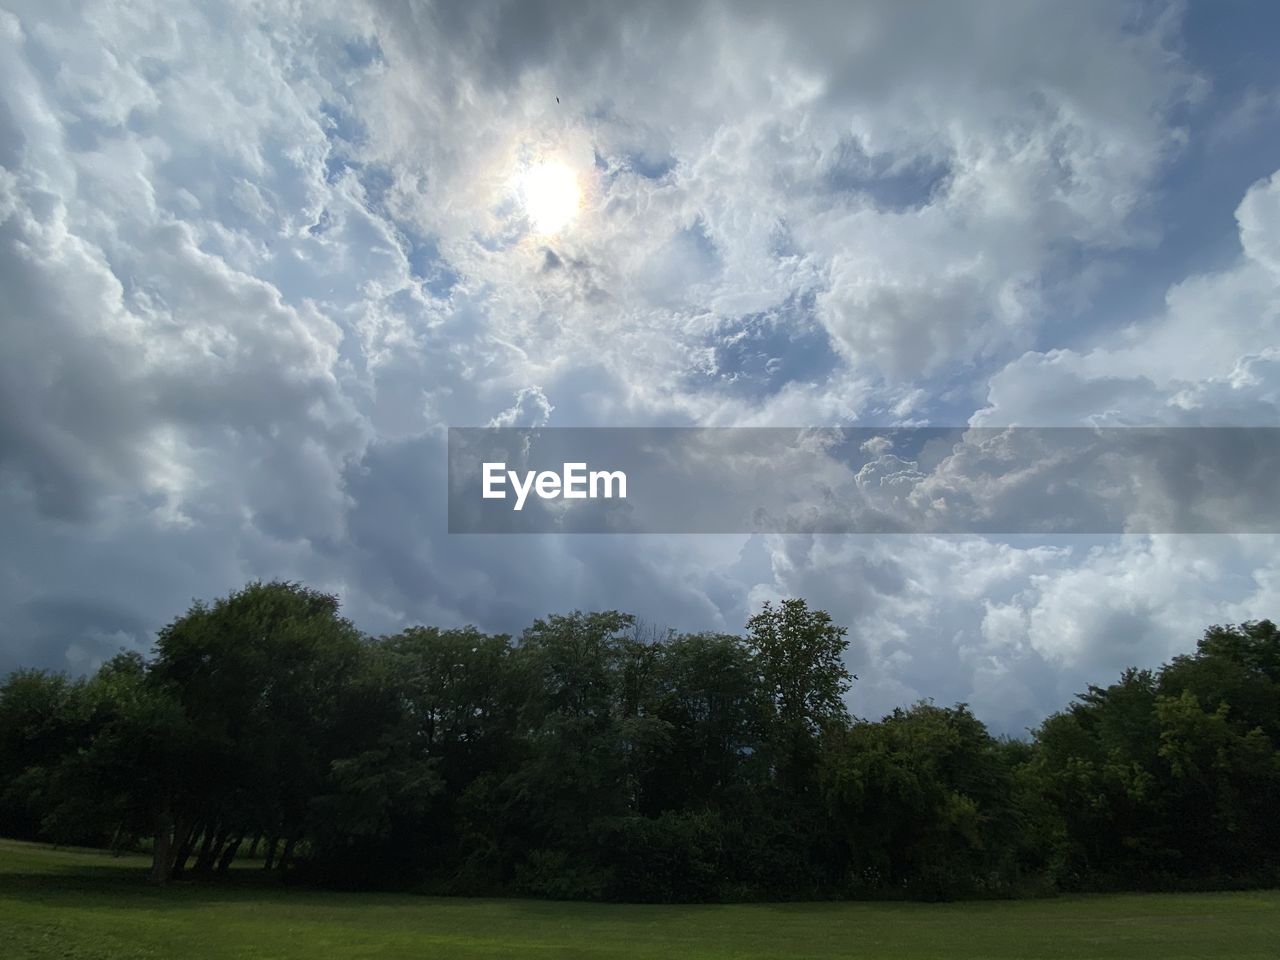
[345,4,1196,416]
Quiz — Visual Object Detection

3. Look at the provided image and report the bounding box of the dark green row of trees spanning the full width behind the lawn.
[0,582,1280,901]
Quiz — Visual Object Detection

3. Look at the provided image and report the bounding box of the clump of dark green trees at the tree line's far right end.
[1034,621,1280,887]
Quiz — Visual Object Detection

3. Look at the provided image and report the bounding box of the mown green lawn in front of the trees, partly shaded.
[0,841,1280,960]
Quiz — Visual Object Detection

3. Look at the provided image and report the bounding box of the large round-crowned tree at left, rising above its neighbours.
[150,582,366,882]
